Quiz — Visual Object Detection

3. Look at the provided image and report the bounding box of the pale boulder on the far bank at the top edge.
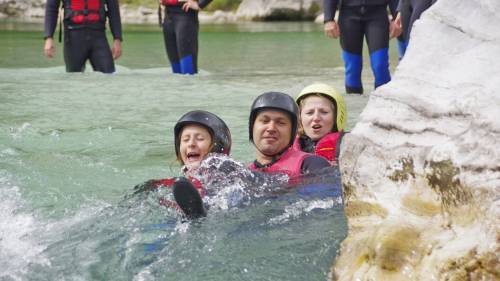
[236,0,323,20]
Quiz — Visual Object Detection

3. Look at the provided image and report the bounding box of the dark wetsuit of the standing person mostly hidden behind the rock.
[398,0,435,59]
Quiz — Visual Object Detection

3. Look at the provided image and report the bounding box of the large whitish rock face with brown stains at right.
[332,0,500,280]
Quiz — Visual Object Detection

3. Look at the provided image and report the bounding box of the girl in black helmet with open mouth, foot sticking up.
[135,110,231,219]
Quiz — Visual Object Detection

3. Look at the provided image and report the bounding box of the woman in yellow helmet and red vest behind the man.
[293,83,347,165]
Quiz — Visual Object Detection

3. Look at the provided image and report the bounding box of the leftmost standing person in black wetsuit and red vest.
[44,0,122,73]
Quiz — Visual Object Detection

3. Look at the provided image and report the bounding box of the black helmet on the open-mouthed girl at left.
[174,110,231,157]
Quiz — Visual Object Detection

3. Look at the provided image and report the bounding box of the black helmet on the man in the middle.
[248,92,299,146]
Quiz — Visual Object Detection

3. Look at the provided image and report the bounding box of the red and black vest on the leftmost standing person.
[64,0,106,29]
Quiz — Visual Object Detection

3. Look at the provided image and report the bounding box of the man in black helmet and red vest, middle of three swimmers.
[249,92,330,180]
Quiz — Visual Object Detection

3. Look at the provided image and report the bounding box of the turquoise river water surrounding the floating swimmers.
[0,22,396,280]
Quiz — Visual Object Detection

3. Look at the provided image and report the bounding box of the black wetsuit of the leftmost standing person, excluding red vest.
[45,0,122,73]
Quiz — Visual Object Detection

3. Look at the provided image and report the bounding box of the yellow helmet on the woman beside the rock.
[295,83,347,132]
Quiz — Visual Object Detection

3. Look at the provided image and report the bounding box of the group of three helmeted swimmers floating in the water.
[138,83,347,219]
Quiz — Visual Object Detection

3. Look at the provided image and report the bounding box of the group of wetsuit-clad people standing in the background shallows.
[44,0,436,94]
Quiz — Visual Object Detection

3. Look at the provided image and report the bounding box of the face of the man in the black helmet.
[252,110,292,160]
